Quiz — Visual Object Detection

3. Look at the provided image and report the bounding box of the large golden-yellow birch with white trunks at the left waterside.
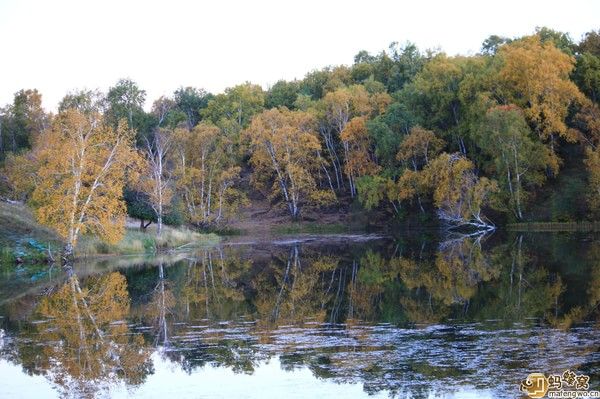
[31,109,137,261]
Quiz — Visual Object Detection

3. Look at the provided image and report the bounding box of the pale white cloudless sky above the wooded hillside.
[0,0,600,110]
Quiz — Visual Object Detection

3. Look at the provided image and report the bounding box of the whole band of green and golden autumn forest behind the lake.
[0,27,600,258]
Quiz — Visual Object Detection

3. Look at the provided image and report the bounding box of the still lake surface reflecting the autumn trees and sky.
[0,234,600,399]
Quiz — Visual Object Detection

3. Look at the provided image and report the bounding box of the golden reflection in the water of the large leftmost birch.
[36,273,151,397]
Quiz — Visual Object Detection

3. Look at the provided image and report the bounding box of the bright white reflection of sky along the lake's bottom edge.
[0,354,492,399]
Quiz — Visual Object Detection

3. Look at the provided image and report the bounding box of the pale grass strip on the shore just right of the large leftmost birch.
[75,226,219,257]
